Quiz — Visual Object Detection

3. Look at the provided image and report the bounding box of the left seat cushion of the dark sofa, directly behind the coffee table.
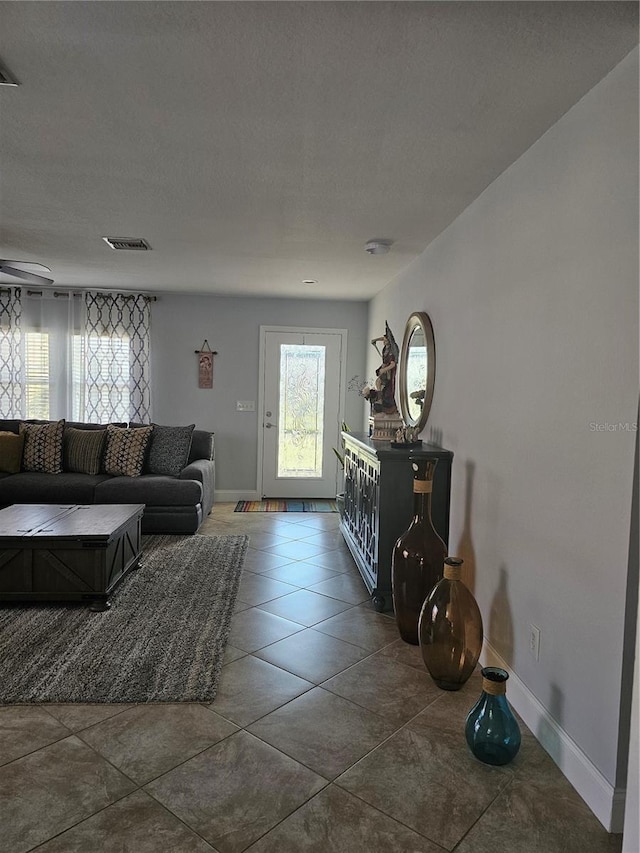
[0,471,110,504]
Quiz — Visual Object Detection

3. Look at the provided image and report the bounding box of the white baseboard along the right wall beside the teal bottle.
[481,640,626,832]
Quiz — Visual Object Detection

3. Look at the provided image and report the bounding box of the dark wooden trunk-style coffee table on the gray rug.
[0,504,144,610]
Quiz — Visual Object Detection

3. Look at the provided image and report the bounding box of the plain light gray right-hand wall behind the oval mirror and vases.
[368,50,638,823]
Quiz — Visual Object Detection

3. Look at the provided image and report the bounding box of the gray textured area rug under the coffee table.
[0,534,249,704]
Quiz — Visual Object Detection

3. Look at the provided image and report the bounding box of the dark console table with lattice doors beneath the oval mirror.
[340,432,453,611]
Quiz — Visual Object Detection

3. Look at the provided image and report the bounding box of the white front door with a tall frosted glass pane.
[261,327,347,498]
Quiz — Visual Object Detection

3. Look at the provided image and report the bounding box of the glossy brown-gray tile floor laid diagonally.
[0,504,621,853]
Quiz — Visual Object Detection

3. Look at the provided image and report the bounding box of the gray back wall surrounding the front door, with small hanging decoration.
[151,294,367,494]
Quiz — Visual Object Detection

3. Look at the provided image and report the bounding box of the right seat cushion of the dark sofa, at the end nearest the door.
[95,474,202,506]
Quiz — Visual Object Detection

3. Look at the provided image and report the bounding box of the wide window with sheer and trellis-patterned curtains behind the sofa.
[0,288,151,423]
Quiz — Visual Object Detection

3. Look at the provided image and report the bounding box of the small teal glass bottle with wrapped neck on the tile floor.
[465,666,521,765]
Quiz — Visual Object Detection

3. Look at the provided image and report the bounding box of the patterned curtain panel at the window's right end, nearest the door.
[82,291,151,423]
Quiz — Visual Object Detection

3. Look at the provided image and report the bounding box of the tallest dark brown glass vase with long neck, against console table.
[391,457,447,646]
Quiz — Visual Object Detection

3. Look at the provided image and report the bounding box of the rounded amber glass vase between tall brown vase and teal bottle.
[418,557,482,690]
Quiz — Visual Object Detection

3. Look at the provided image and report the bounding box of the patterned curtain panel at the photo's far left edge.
[0,287,24,418]
